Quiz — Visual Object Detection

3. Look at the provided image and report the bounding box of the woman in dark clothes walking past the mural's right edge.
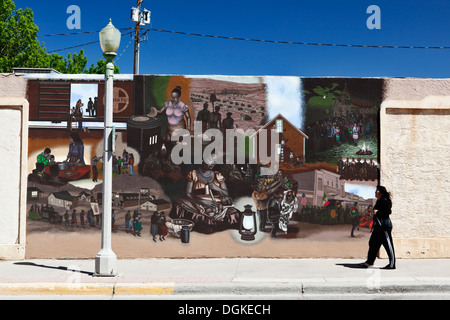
[361,186,395,269]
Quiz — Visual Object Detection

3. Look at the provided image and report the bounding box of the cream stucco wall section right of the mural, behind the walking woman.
[380,79,450,258]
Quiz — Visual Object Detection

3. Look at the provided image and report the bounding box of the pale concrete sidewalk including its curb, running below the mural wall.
[0,258,450,300]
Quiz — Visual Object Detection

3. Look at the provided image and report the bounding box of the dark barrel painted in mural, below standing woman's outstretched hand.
[127,115,162,156]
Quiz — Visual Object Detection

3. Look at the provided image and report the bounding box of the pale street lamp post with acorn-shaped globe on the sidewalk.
[95,20,121,277]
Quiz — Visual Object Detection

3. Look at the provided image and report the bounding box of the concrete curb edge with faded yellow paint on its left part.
[0,282,450,298]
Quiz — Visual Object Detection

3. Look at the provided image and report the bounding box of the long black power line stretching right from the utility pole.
[150,28,450,49]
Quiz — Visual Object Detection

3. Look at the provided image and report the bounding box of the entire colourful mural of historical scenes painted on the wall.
[27,76,382,255]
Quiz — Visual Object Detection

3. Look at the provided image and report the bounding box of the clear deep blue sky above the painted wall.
[15,0,450,78]
